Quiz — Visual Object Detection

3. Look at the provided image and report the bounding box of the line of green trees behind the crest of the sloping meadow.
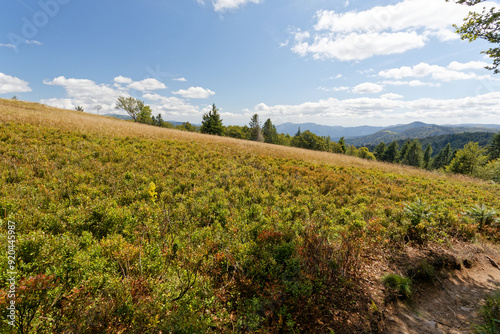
[116,97,500,182]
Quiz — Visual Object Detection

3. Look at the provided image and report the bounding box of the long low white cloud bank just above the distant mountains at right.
[247,92,500,124]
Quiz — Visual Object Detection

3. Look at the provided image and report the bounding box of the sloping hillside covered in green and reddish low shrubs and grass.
[0,100,500,333]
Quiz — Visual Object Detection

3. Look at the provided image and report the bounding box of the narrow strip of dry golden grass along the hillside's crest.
[0,99,492,184]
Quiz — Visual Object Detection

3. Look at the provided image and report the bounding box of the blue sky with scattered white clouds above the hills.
[0,0,500,126]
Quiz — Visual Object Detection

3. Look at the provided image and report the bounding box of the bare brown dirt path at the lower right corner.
[384,246,500,334]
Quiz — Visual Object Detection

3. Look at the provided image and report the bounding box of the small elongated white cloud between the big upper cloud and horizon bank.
[378,62,491,82]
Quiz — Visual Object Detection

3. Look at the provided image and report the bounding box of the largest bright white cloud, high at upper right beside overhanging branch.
[292,0,494,61]
